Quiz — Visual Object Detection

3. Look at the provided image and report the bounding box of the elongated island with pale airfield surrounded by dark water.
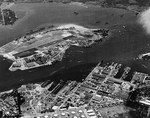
[0,24,109,71]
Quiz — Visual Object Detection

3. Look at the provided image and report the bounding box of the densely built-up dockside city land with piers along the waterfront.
[0,61,150,118]
